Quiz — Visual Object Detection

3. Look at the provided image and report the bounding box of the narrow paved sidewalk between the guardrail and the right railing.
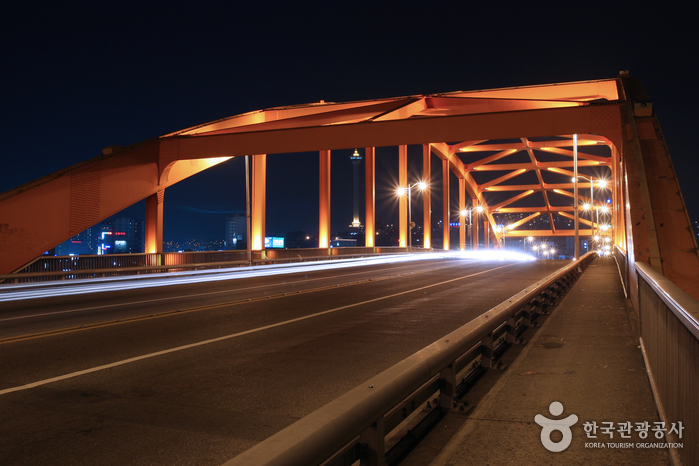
[424,258,670,466]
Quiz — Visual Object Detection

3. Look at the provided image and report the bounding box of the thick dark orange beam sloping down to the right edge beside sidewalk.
[620,73,699,299]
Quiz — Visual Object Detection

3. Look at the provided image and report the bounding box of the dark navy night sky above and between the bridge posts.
[0,0,699,244]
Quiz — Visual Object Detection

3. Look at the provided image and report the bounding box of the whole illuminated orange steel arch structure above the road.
[0,72,699,298]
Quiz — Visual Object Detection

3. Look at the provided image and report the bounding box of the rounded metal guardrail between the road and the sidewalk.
[224,253,594,466]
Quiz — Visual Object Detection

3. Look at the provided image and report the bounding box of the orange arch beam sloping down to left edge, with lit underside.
[0,141,230,273]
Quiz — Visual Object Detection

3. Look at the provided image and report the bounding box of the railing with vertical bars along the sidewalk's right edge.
[635,262,699,465]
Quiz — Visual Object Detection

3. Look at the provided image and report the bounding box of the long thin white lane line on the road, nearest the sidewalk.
[0,263,516,396]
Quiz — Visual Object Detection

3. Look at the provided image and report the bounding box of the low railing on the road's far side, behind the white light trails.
[0,246,425,283]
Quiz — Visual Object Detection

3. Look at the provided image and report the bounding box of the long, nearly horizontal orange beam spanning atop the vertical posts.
[167,105,621,165]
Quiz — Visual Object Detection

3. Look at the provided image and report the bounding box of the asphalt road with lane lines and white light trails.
[0,257,565,465]
